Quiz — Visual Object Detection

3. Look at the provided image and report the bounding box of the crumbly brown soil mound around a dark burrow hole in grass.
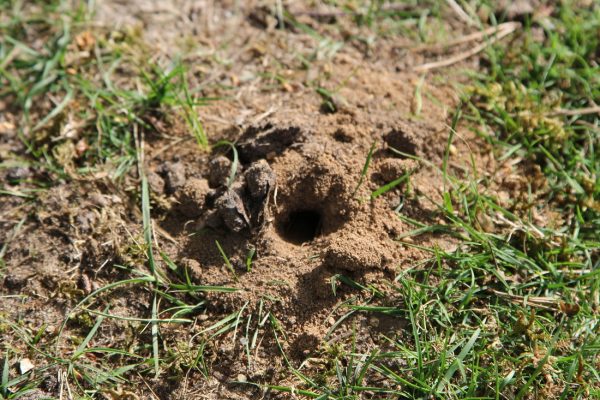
[156,101,450,337]
